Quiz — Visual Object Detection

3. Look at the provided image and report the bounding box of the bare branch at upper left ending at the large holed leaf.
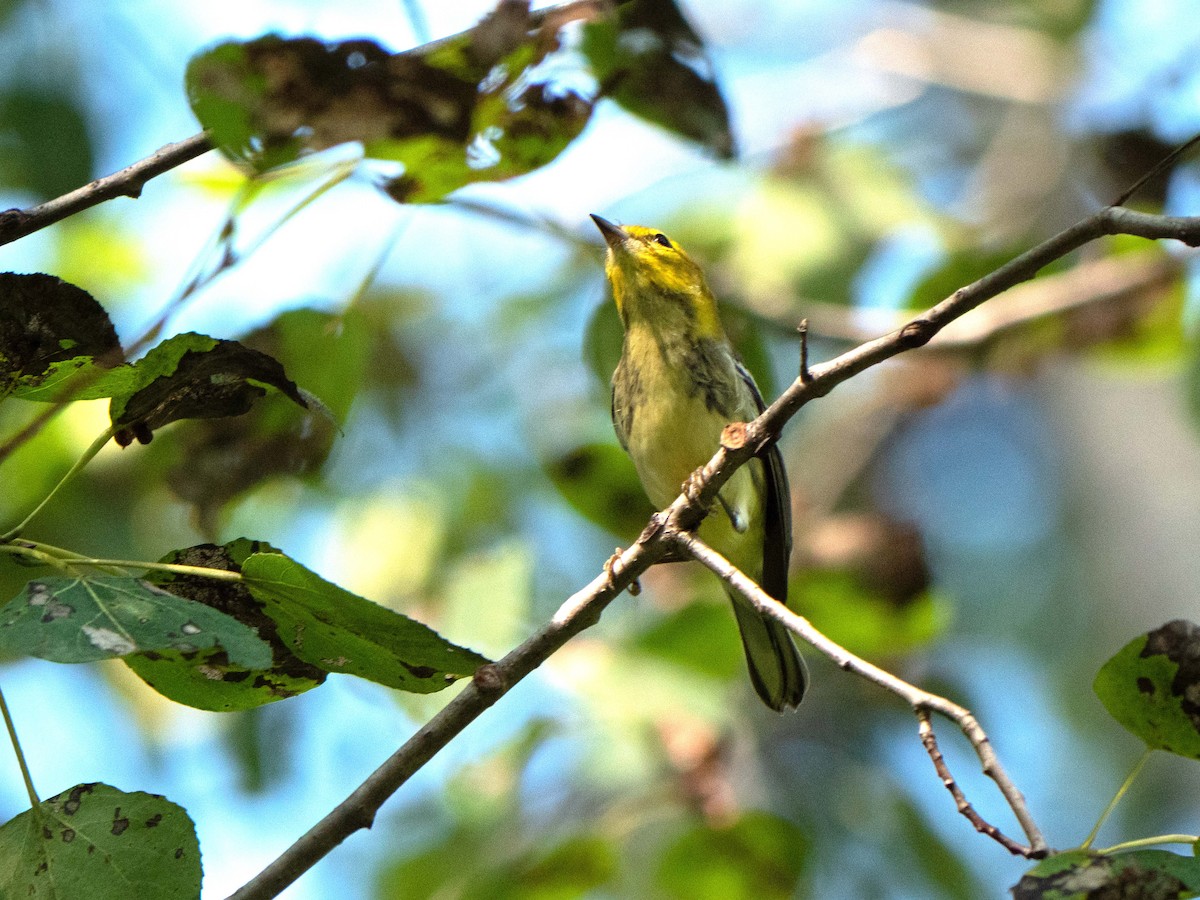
[0,132,212,246]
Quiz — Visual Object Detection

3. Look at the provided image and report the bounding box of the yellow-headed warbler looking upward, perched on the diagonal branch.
[592,215,808,710]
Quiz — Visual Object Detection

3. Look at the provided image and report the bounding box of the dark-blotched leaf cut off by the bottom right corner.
[1013,850,1200,900]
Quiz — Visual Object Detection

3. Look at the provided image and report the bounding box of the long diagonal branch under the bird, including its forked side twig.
[230,208,1200,900]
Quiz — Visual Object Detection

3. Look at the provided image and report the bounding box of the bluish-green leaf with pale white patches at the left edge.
[0,576,270,666]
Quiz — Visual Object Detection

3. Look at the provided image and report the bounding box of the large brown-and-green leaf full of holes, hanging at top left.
[187,0,596,202]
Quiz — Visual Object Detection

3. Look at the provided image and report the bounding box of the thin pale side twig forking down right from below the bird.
[664,530,1049,859]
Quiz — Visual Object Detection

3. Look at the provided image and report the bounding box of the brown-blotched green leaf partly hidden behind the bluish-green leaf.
[125,538,325,712]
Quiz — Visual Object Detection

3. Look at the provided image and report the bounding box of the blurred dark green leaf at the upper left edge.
[0,90,92,200]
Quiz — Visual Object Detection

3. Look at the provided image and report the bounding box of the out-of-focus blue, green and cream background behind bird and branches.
[0,0,1200,900]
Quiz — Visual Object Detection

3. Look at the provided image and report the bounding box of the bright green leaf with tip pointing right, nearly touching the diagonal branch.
[241,553,488,694]
